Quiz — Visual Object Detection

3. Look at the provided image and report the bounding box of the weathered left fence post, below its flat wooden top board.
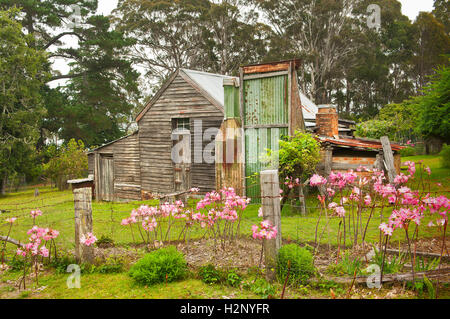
[73,187,94,264]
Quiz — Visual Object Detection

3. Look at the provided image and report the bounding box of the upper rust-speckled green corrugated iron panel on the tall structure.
[244,75,289,125]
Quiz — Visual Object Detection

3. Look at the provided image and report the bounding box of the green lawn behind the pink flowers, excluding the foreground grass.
[0,156,450,255]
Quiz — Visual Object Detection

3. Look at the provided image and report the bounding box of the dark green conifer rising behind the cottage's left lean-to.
[57,16,140,147]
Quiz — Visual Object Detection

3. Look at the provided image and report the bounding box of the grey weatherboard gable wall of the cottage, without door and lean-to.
[138,71,223,194]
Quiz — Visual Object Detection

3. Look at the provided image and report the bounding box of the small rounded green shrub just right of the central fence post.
[277,244,314,284]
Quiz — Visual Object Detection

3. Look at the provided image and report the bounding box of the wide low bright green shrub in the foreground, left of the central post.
[129,246,187,285]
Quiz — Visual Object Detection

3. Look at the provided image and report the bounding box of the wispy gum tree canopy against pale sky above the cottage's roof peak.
[116,0,270,84]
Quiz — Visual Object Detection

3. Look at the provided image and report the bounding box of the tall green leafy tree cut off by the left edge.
[0,8,48,185]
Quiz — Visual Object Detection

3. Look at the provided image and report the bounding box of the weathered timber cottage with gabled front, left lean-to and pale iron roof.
[88,69,241,201]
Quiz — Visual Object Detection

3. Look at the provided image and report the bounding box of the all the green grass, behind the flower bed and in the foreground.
[0,156,450,299]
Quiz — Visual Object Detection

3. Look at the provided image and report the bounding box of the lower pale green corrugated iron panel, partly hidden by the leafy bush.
[245,128,288,203]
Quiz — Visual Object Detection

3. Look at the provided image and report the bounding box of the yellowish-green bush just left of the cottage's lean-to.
[44,139,88,189]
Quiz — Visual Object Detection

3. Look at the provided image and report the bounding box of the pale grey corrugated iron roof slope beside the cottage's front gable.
[181,69,239,107]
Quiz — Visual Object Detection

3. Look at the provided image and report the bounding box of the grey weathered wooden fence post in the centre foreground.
[261,170,281,281]
